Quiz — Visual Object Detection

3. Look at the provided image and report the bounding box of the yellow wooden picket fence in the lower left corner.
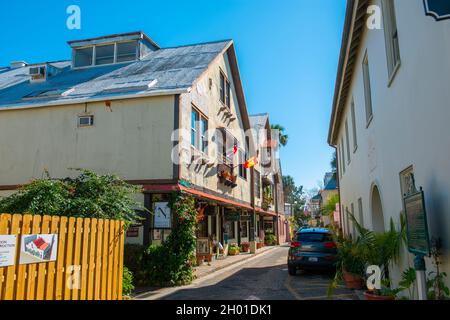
[0,214,124,300]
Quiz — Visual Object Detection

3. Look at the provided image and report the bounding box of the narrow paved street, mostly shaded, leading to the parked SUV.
[148,246,358,300]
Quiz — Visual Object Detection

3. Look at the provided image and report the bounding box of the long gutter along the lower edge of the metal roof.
[0,87,191,112]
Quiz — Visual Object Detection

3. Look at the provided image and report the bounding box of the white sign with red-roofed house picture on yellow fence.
[19,234,58,264]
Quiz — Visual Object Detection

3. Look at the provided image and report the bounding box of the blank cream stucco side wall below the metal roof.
[0,96,174,185]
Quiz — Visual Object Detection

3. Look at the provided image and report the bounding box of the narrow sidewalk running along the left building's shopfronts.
[131,245,281,300]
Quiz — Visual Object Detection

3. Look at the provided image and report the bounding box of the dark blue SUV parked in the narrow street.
[288,228,337,275]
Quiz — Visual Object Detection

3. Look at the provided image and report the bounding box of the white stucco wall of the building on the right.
[338,0,450,288]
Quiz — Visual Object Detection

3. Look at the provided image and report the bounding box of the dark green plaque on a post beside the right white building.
[404,191,430,256]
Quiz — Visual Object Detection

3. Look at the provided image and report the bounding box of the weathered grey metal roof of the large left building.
[0,40,232,110]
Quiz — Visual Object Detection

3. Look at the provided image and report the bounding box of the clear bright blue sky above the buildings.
[0,0,346,188]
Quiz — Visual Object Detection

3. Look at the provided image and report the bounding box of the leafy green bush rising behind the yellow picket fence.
[0,169,141,226]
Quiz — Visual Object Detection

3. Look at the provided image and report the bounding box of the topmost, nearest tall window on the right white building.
[383,0,400,81]
